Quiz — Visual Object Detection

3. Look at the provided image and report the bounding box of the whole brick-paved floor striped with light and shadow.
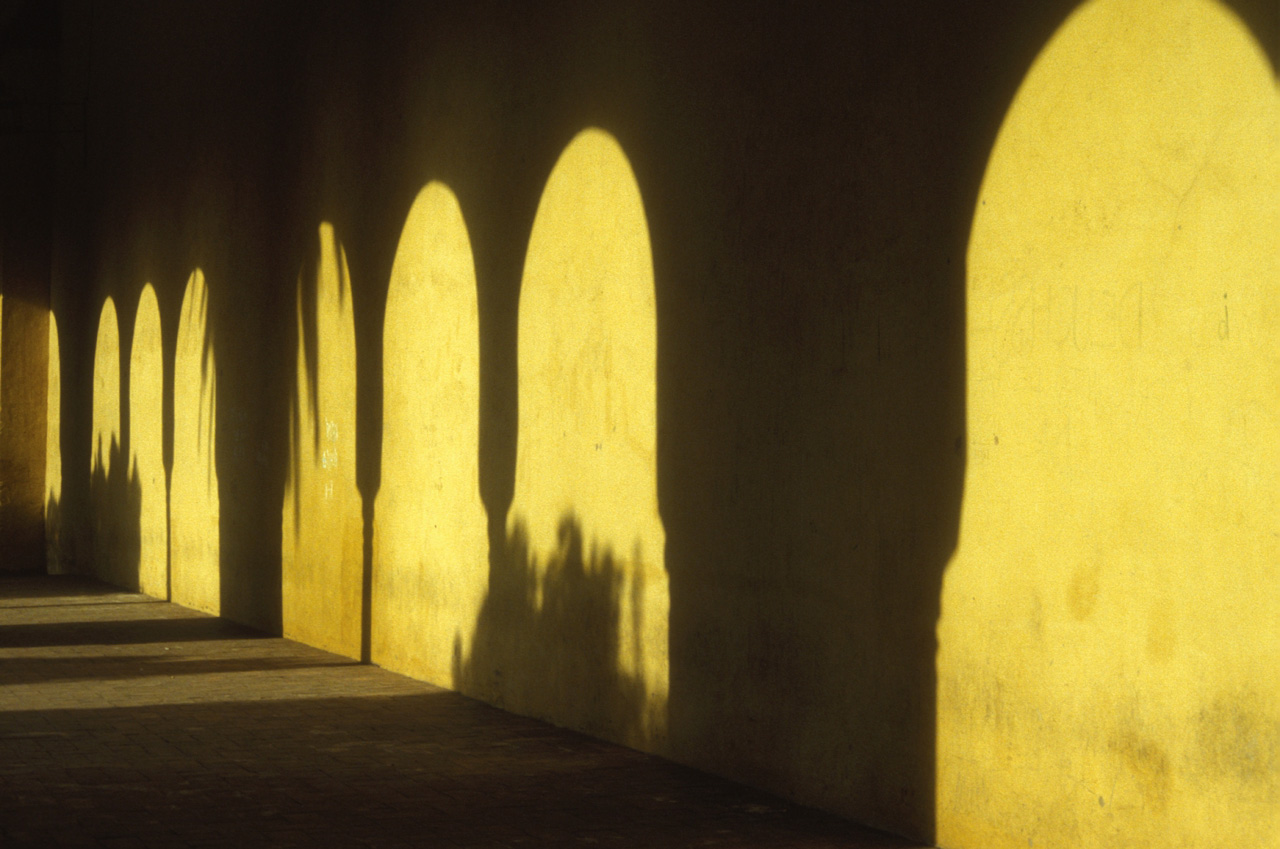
[0,576,926,849]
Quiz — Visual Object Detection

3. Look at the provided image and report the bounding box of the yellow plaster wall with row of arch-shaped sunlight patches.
[35,0,1280,848]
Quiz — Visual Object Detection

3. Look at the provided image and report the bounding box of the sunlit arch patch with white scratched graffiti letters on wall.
[282,223,364,657]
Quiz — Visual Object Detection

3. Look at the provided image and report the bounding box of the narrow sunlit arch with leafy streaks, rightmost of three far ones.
[169,269,221,613]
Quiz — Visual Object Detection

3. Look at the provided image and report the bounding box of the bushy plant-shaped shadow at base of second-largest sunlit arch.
[453,513,650,740]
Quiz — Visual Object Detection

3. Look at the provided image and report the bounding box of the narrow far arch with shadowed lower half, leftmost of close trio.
[90,297,128,588]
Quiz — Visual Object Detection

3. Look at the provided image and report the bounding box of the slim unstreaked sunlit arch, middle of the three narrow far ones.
[129,283,169,598]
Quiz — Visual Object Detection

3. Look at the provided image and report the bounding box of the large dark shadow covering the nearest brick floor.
[0,691,911,849]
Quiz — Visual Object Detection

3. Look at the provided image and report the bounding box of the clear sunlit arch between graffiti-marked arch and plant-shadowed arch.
[372,183,489,688]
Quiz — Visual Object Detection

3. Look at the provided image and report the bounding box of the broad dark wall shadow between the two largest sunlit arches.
[604,3,1069,843]
